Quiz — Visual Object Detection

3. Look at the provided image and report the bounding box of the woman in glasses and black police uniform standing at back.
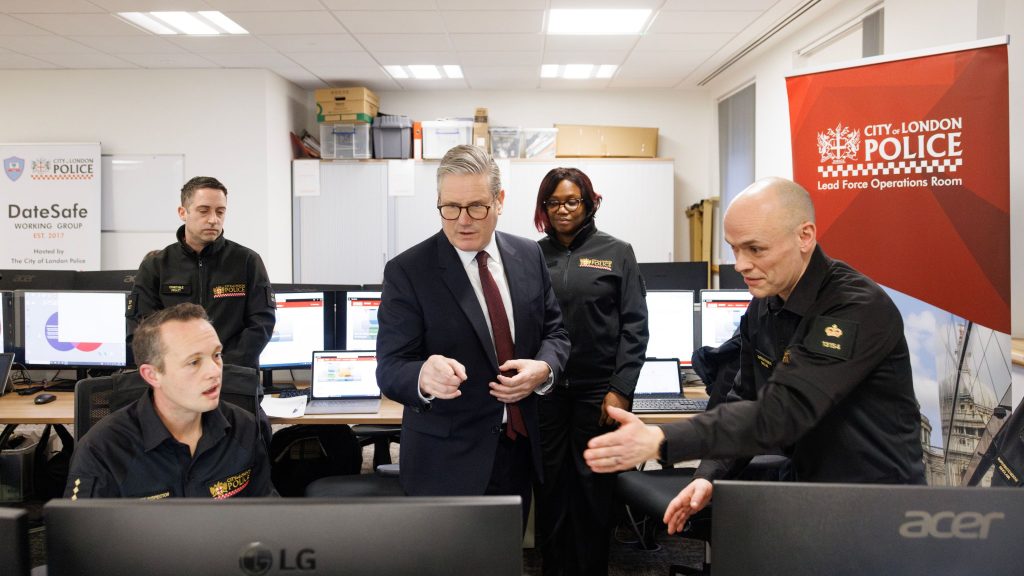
[534,168,647,576]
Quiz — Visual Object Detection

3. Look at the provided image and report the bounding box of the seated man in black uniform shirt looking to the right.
[65,303,273,500]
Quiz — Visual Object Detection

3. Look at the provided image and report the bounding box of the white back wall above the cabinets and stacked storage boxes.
[378,89,717,260]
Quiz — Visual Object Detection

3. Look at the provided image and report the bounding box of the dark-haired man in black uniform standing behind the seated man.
[129,176,276,368]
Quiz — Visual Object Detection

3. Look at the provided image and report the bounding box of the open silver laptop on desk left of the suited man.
[306,351,381,414]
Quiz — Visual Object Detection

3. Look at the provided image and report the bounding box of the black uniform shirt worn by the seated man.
[65,390,273,499]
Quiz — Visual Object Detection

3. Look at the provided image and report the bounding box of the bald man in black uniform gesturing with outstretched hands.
[586,178,925,532]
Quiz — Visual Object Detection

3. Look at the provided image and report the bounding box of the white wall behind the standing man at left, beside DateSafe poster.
[0,70,309,282]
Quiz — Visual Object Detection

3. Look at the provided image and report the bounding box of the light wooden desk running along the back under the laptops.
[0,388,703,424]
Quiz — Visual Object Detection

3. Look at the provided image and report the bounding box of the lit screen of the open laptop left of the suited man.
[310,351,381,399]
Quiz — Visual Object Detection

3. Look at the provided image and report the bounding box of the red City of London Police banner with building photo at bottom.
[786,38,1013,485]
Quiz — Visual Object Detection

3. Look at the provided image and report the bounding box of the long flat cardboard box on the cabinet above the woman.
[555,124,657,158]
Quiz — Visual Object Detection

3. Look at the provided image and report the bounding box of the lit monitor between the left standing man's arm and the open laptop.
[259,292,334,369]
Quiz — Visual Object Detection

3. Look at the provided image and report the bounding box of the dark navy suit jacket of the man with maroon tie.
[377,232,569,495]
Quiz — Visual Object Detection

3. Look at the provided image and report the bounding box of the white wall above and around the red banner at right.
[708,0,1024,336]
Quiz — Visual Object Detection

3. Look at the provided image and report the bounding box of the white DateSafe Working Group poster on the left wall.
[0,142,101,271]
